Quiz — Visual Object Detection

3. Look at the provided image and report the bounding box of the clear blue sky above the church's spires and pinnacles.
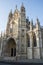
[0,0,43,32]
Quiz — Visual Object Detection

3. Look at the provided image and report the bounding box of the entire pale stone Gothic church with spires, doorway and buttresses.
[0,4,43,60]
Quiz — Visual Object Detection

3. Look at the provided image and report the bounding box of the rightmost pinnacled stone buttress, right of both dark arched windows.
[34,18,41,59]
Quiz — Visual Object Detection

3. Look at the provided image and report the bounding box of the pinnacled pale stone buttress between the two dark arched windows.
[27,20,33,59]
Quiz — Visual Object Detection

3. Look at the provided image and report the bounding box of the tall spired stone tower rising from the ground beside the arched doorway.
[20,3,26,59]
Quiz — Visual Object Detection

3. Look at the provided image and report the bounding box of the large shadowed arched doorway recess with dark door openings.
[5,38,16,57]
